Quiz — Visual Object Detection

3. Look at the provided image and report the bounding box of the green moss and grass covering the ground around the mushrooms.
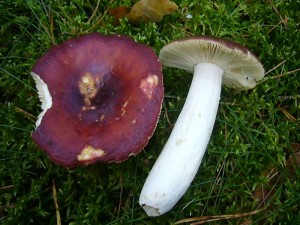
[0,0,300,225]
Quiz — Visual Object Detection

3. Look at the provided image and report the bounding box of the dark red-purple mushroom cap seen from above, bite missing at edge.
[31,33,163,167]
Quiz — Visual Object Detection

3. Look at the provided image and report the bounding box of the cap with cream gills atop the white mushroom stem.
[159,36,264,89]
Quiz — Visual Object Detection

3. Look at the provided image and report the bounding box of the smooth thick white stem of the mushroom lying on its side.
[139,63,224,216]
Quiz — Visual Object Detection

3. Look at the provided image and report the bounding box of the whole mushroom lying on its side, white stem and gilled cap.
[139,36,264,216]
